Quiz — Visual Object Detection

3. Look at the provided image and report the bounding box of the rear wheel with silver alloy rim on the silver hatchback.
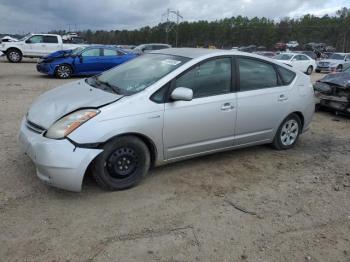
[272,114,301,150]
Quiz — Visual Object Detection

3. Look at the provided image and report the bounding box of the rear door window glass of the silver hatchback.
[238,58,278,91]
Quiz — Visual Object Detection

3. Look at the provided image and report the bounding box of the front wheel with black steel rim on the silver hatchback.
[91,136,151,191]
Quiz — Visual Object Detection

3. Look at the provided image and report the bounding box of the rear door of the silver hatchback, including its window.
[235,57,295,145]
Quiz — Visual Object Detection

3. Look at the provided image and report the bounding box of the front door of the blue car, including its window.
[75,48,104,75]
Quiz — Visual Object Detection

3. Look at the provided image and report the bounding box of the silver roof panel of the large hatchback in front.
[150,48,230,58]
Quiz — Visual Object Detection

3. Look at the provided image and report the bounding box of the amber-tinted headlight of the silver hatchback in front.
[45,109,100,139]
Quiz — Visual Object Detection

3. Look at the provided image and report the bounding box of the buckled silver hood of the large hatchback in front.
[27,80,123,129]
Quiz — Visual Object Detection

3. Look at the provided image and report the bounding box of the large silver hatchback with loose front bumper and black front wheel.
[19,48,315,191]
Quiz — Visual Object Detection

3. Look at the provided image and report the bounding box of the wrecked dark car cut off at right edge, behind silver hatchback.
[314,67,350,114]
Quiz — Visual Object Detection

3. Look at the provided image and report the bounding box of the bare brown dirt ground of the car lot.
[0,58,350,261]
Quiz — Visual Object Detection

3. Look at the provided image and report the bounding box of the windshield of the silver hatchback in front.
[88,54,189,95]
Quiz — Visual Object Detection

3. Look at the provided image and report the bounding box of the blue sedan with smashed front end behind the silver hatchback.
[36,46,137,78]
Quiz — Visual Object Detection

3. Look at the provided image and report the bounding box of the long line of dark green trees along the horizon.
[51,8,350,51]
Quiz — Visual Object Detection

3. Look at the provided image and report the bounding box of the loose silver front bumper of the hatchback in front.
[19,119,102,192]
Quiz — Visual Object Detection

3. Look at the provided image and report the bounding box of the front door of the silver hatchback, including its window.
[163,57,236,160]
